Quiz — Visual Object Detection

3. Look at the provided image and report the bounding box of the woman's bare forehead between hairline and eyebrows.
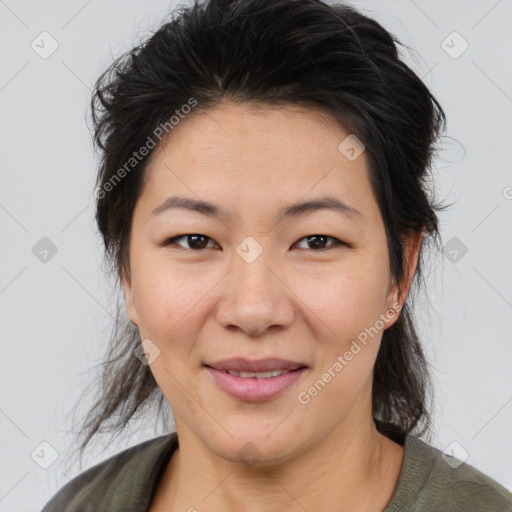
[138,103,378,225]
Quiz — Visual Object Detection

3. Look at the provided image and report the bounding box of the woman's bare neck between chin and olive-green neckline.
[151,421,403,512]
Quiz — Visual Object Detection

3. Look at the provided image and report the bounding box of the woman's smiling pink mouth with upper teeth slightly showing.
[203,358,309,402]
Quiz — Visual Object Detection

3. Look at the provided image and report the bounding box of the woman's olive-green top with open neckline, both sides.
[42,432,512,512]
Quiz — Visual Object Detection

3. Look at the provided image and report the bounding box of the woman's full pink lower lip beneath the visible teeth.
[206,366,307,402]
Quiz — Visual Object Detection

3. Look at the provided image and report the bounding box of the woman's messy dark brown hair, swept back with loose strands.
[71,0,446,464]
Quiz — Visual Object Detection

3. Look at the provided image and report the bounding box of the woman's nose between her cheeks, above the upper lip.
[216,247,295,336]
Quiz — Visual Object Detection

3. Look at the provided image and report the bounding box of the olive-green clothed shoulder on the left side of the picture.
[42,432,178,512]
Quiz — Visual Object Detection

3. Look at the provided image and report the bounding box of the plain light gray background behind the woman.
[0,0,512,512]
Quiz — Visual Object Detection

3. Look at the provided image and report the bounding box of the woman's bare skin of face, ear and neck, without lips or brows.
[122,102,421,512]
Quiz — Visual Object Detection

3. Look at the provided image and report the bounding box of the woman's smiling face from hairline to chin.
[123,103,417,463]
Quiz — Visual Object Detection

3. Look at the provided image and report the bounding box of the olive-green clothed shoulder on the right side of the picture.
[385,436,512,512]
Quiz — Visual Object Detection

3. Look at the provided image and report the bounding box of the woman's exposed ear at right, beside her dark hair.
[387,230,423,327]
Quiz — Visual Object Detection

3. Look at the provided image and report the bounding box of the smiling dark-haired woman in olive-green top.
[43,0,512,512]
